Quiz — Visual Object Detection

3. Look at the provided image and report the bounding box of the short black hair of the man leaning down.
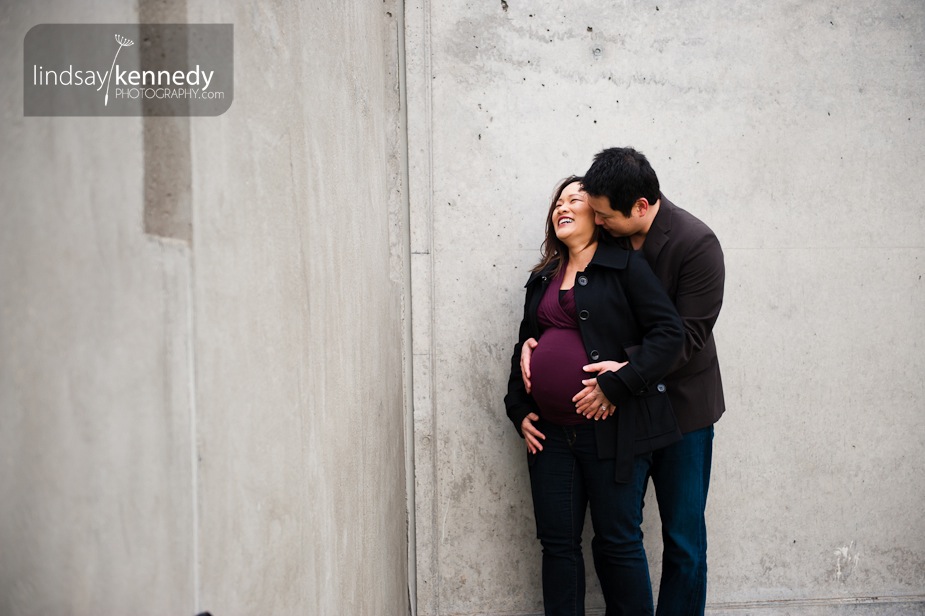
[582,148,659,216]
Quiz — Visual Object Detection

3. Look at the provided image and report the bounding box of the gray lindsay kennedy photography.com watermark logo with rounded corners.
[23,24,234,116]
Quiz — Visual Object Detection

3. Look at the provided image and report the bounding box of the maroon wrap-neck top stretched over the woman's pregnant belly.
[530,268,594,426]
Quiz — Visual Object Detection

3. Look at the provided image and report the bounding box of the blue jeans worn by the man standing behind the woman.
[650,426,713,616]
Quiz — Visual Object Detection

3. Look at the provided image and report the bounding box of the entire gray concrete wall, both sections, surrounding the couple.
[0,0,925,616]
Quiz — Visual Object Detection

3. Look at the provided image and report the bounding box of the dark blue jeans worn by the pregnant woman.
[530,422,653,616]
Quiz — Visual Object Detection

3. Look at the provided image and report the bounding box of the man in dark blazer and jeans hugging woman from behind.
[521,148,725,616]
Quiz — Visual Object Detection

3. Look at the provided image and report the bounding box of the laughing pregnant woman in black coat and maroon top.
[504,176,682,616]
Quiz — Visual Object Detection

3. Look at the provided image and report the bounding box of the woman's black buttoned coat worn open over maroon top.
[504,239,684,482]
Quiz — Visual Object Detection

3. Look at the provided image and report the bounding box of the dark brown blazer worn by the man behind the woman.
[642,195,726,433]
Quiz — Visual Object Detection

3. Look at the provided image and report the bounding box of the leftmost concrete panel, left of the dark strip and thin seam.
[0,3,195,615]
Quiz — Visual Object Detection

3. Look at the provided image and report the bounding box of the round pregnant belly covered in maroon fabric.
[530,328,594,424]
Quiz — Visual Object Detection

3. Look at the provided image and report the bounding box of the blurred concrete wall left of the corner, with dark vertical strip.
[0,0,410,616]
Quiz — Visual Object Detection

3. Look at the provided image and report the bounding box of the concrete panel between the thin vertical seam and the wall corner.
[190,2,409,615]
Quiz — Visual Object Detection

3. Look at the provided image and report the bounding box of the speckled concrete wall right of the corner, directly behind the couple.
[406,0,925,615]
